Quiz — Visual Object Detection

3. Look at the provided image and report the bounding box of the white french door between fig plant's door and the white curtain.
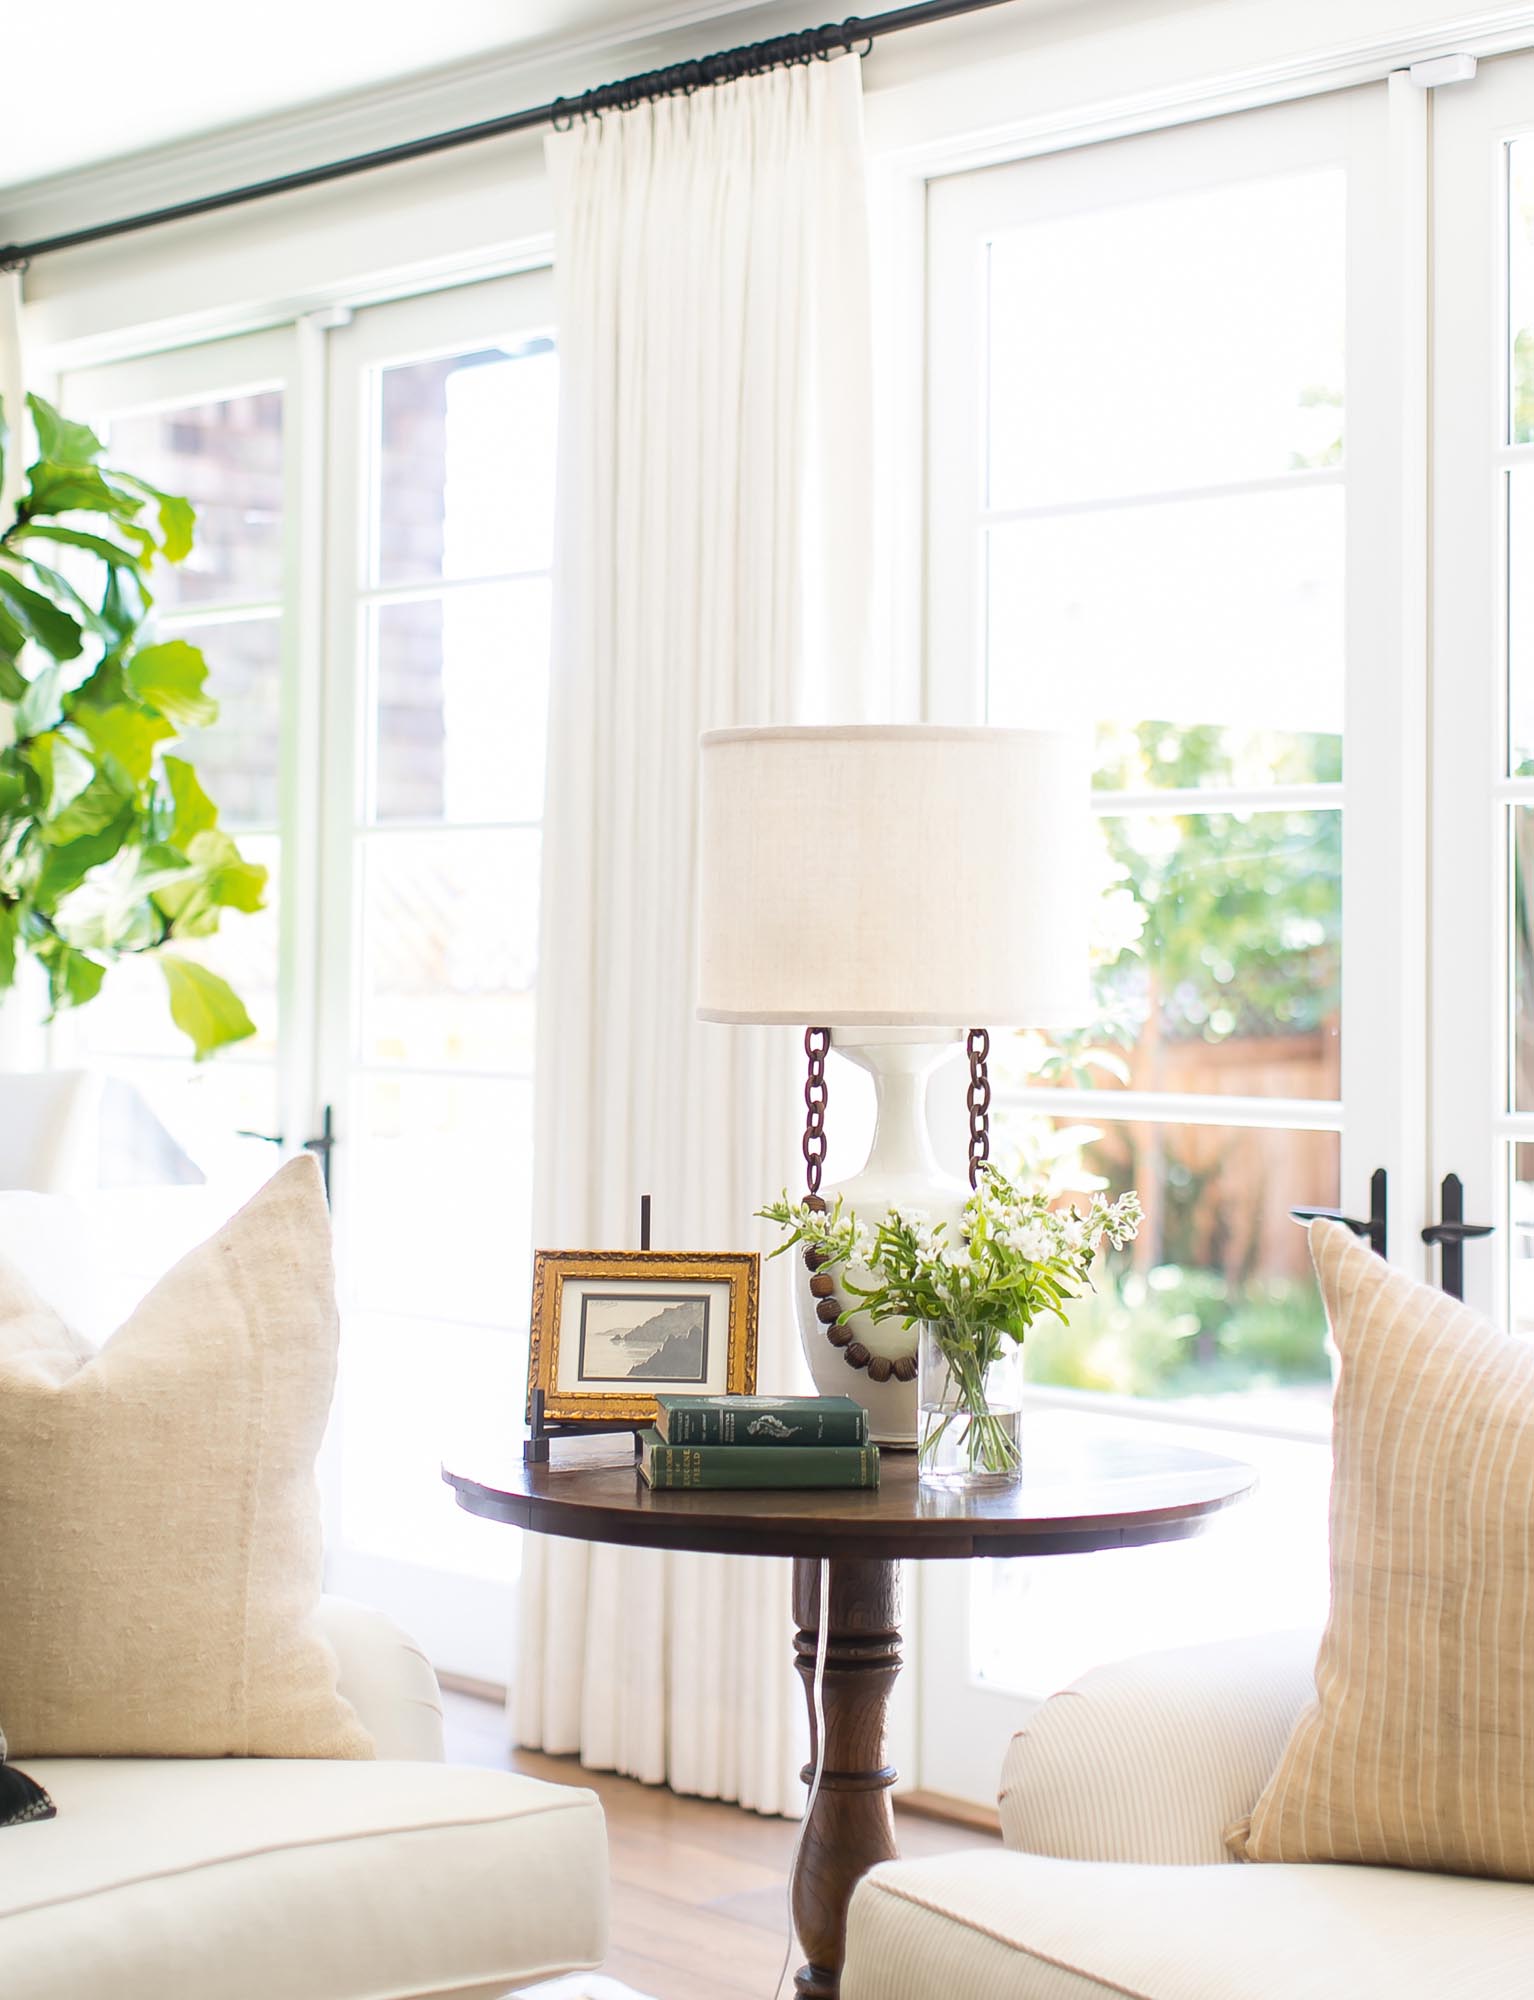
[322,278,556,1682]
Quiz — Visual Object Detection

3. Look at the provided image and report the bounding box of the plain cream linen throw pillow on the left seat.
[0,1156,374,1758]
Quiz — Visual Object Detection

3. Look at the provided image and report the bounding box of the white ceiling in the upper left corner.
[0,0,768,188]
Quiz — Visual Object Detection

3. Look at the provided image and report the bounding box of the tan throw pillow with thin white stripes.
[1228,1222,1534,1882]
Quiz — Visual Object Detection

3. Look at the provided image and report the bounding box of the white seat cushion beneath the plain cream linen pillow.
[0,1758,612,2000]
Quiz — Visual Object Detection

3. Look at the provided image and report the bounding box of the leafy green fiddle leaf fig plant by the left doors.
[0,396,266,1060]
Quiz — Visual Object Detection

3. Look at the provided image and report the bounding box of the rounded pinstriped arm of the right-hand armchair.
[1000,1632,1318,1864]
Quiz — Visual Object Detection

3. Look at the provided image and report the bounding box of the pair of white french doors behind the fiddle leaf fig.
[54,272,556,1682]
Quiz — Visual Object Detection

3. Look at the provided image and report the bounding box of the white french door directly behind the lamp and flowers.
[918,84,1426,1800]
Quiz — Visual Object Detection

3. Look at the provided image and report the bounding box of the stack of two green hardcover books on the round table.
[640,1396,878,1488]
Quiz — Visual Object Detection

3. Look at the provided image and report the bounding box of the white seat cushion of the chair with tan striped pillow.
[842,1850,1534,2000]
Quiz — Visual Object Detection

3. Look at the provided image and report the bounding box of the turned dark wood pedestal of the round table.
[792,1556,900,2000]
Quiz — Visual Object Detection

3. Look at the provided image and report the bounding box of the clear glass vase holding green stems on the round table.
[916,1320,1022,1492]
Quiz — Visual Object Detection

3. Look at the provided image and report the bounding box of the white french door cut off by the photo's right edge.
[1430,54,1534,1336]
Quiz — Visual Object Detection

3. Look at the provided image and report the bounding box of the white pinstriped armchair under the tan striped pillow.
[842,1632,1534,2000]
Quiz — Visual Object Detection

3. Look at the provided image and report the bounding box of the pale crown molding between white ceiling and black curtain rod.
[0,0,804,242]
